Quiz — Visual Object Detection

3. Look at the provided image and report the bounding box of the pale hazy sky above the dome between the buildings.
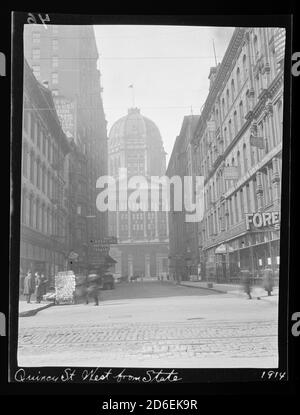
[94,25,234,161]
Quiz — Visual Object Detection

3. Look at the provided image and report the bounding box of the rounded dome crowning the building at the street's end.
[109,108,163,147]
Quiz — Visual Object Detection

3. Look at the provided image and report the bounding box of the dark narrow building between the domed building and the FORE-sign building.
[166,115,199,281]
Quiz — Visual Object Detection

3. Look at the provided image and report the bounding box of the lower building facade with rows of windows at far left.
[20,61,71,277]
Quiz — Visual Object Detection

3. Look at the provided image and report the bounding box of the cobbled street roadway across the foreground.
[18,282,278,368]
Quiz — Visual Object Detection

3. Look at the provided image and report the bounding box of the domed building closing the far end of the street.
[108,108,169,278]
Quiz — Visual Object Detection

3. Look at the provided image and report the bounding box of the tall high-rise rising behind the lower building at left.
[24,25,107,270]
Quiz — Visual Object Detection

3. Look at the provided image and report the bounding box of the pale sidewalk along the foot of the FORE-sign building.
[180,281,278,298]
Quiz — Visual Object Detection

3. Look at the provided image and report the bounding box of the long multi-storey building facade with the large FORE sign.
[193,28,285,281]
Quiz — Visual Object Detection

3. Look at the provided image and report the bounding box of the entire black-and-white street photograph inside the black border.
[11,14,288,370]
